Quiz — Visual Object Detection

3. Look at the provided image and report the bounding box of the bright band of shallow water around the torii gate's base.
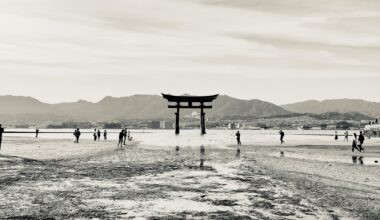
[4,129,380,147]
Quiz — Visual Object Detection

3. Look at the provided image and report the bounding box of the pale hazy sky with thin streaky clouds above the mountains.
[0,0,380,104]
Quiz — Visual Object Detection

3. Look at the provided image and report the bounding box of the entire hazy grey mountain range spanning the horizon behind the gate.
[0,95,380,123]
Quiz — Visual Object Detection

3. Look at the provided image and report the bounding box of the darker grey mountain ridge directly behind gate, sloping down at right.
[0,95,290,122]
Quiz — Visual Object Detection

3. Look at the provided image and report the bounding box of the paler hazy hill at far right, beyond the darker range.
[281,99,380,117]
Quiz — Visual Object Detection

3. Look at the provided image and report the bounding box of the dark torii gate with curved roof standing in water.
[162,93,218,134]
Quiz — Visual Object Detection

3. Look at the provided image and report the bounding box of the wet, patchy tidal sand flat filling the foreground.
[0,137,380,219]
